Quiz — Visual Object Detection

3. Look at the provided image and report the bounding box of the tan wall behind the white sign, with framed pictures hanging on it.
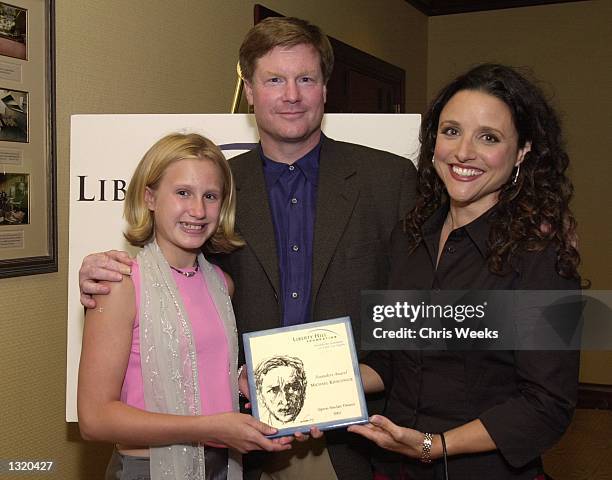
[0,0,427,480]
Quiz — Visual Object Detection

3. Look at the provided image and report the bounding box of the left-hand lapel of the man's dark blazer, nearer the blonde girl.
[230,149,280,298]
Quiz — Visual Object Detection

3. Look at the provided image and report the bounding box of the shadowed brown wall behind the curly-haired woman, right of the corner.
[427,0,612,385]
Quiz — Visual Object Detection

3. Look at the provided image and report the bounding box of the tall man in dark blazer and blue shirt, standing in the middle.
[81,18,416,480]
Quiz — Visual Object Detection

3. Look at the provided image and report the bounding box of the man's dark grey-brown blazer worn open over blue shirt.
[214,137,416,480]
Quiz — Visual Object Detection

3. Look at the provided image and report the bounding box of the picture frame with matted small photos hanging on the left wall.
[0,0,58,278]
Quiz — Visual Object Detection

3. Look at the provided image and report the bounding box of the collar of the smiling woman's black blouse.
[421,202,496,258]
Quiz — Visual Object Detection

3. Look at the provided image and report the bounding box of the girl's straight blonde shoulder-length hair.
[123,133,244,253]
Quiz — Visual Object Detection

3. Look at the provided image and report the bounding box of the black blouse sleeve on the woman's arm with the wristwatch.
[480,248,580,467]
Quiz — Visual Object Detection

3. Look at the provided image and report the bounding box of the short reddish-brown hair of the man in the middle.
[239,17,334,83]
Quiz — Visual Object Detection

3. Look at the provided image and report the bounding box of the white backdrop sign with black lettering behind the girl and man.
[66,114,421,422]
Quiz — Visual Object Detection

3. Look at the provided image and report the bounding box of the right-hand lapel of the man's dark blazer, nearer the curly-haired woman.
[311,138,359,311]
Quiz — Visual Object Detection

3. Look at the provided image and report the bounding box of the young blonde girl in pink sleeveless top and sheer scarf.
[78,134,291,480]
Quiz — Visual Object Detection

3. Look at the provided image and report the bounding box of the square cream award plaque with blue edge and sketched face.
[243,317,368,437]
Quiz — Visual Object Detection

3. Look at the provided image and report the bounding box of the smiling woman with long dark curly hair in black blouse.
[349,64,580,480]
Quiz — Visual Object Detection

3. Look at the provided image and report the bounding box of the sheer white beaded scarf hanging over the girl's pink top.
[138,241,242,480]
